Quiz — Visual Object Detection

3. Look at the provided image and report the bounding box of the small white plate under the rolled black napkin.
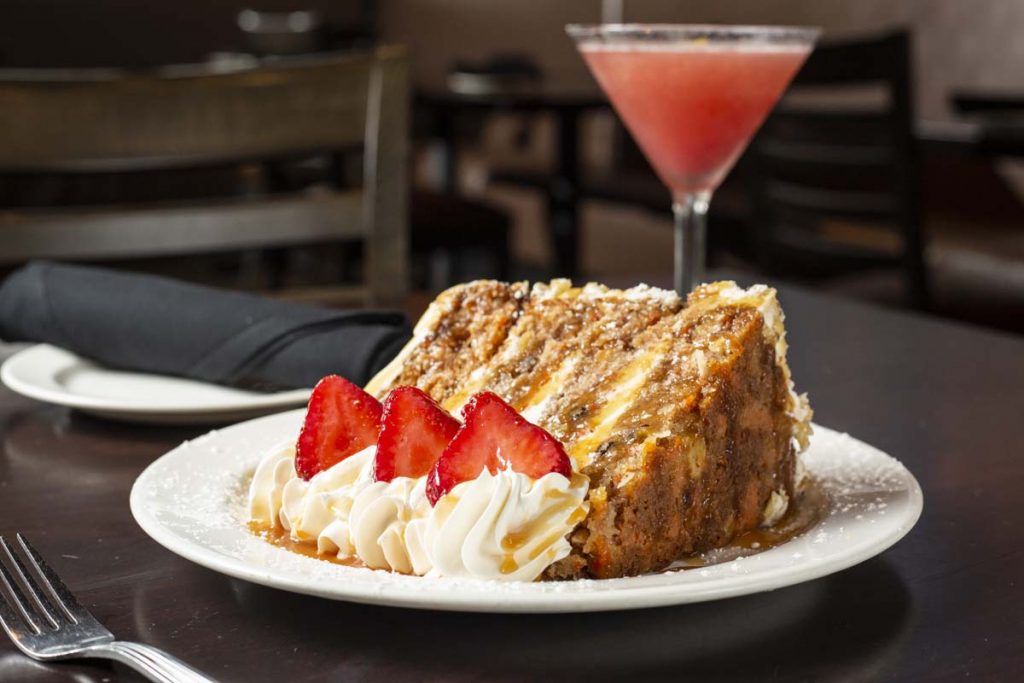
[0,344,310,424]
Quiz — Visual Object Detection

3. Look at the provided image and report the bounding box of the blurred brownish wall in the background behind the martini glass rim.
[380,0,1024,118]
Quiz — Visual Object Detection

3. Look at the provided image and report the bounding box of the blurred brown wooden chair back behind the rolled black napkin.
[0,47,410,305]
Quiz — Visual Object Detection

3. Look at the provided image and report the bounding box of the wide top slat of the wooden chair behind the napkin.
[0,54,388,170]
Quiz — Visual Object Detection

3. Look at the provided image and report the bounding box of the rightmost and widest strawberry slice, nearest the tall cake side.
[427,391,572,505]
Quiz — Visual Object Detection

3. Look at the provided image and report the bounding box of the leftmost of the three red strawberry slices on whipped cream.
[295,375,381,480]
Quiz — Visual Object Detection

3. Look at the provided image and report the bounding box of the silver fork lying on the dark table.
[0,533,213,683]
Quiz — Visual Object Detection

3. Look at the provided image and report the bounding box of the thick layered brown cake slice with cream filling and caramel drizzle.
[367,280,811,579]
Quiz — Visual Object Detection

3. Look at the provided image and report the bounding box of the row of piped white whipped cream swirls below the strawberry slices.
[243,446,589,581]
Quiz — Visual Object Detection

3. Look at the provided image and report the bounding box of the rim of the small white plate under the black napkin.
[0,343,311,416]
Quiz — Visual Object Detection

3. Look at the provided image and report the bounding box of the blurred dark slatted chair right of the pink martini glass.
[746,32,929,307]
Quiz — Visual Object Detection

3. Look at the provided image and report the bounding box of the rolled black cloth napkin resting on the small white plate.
[0,262,411,390]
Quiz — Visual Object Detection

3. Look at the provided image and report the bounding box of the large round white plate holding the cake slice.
[131,411,922,612]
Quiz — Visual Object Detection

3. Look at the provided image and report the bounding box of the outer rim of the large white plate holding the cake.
[129,410,924,613]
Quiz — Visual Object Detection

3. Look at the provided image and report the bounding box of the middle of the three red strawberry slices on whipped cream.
[374,387,459,481]
